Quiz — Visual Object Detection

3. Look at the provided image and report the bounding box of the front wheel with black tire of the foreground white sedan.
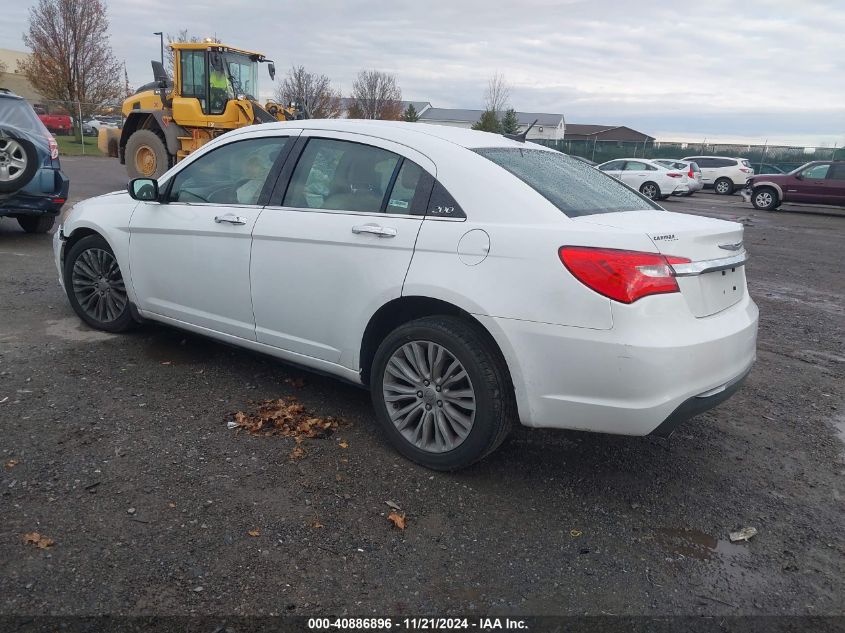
[64,235,136,332]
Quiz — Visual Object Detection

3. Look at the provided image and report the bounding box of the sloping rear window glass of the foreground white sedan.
[474,147,660,218]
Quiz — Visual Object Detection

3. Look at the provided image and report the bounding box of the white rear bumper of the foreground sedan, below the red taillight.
[480,294,758,435]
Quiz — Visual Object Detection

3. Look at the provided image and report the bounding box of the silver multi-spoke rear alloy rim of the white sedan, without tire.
[382,341,476,453]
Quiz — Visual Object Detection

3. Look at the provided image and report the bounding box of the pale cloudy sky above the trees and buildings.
[0,0,845,146]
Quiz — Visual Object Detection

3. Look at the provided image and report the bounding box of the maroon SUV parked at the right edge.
[742,160,845,211]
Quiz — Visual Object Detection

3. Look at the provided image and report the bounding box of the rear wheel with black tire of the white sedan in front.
[370,316,517,471]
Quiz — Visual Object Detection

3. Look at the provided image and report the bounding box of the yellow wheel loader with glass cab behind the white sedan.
[98,41,303,178]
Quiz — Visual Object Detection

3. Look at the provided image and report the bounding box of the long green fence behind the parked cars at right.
[533,139,845,172]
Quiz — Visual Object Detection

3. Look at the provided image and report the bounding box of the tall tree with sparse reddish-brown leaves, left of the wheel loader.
[18,0,122,130]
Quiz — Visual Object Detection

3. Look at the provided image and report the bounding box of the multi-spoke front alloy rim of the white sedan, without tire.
[71,248,128,323]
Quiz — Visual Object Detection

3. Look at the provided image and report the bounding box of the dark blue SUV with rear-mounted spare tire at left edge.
[0,88,70,233]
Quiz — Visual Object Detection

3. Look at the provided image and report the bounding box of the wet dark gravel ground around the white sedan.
[0,158,845,615]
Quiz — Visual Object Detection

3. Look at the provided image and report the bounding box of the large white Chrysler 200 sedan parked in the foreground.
[54,120,758,470]
